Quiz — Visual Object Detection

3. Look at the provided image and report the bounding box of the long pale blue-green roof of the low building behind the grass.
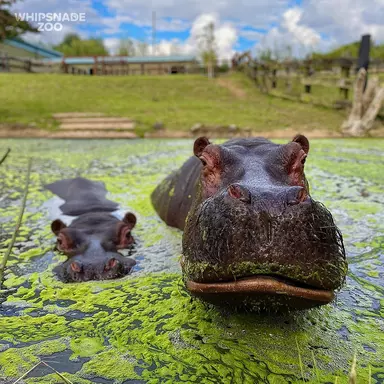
[44,55,196,65]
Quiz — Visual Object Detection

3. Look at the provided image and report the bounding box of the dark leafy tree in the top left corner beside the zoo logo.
[0,0,39,41]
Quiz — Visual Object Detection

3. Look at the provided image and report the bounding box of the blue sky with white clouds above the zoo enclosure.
[9,0,384,59]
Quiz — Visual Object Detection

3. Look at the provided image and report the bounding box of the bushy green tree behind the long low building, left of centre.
[54,33,108,56]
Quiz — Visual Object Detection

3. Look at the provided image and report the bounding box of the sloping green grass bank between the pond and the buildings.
[0,74,344,131]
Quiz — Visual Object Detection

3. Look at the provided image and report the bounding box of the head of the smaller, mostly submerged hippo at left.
[51,213,136,282]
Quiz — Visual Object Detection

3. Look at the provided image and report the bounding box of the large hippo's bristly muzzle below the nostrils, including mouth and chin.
[182,193,347,308]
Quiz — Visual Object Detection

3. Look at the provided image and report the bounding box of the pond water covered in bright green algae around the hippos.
[0,139,384,384]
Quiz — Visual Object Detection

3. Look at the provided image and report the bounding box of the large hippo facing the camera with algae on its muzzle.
[151,135,348,311]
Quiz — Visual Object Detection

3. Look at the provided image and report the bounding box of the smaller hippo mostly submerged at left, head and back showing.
[45,177,136,282]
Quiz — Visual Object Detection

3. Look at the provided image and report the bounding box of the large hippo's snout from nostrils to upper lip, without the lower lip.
[182,194,347,290]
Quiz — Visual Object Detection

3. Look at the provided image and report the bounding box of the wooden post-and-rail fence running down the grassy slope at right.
[232,53,384,108]
